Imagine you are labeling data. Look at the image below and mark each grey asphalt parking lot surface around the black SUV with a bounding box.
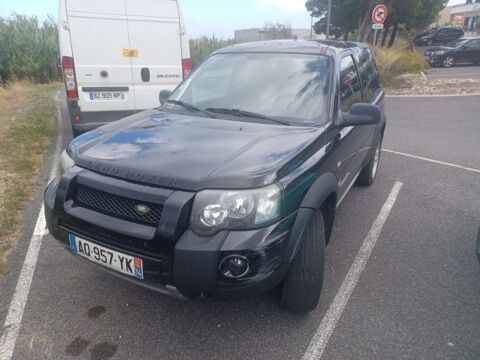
[0,96,480,360]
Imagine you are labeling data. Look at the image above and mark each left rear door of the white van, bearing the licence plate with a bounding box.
[67,0,135,111]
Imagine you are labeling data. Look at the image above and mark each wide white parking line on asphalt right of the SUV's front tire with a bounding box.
[303,182,403,360]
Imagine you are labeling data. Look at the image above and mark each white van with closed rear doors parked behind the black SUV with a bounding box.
[58,0,191,136]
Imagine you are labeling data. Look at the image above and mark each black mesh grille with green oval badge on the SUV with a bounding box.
[76,185,163,225]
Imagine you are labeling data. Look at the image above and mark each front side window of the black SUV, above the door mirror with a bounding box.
[340,56,362,112]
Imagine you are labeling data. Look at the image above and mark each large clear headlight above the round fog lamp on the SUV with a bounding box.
[190,185,282,235]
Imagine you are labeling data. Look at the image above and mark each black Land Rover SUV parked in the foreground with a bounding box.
[45,40,386,312]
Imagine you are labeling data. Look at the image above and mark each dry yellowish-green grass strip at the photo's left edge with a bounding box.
[0,83,59,272]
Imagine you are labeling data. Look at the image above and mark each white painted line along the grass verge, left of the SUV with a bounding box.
[0,99,63,360]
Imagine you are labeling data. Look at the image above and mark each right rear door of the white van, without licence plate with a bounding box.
[125,0,183,110]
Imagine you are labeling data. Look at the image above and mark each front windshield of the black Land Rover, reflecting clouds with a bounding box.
[167,53,331,125]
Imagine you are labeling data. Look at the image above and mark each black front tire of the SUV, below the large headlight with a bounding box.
[280,211,325,313]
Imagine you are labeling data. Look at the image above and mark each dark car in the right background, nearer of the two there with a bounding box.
[425,38,480,67]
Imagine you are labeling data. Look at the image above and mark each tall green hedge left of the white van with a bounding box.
[0,15,61,83]
